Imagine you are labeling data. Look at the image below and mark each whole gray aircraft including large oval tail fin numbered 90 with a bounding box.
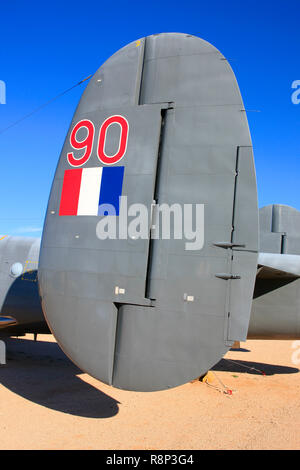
[0,33,300,391]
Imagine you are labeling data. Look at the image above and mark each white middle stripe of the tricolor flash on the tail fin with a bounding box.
[77,167,102,215]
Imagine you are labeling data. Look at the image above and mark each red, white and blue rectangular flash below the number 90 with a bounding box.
[59,166,124,216]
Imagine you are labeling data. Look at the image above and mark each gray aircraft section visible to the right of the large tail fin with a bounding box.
[248,204,300,339]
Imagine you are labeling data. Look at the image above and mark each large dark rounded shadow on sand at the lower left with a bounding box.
[0,338,119,418]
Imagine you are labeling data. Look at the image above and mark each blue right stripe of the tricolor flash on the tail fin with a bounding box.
[98,166,124,215]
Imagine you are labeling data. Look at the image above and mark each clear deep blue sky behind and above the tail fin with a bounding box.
[0,0,300,236]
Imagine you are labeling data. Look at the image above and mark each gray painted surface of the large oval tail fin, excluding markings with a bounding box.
[39,33,258,391]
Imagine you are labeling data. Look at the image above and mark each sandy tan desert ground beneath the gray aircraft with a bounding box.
[0,335,300,450]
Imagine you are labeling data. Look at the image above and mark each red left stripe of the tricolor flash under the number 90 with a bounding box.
[59,168,82,215]
